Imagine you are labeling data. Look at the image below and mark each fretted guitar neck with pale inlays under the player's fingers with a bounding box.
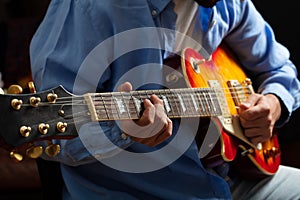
[84,88,222,121]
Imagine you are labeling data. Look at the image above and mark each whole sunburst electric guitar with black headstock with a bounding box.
[0,45,280,178]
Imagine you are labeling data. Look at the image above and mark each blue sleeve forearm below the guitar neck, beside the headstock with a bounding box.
[35,122,132,166]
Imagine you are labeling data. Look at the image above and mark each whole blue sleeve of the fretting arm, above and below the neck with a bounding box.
[30,0,138,165]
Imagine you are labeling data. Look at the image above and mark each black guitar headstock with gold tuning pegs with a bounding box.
[0,82,86,161]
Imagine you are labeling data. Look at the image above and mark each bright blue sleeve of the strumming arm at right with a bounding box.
[226,0,300,126]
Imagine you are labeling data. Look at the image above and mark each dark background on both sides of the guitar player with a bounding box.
[0,0,300,200]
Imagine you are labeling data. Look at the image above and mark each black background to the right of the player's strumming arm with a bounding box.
[253,0,300,154]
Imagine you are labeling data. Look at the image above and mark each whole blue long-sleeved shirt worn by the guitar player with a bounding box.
[30,0,300,199]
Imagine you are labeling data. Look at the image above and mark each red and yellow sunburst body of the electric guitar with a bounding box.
[181,44,280,178]
